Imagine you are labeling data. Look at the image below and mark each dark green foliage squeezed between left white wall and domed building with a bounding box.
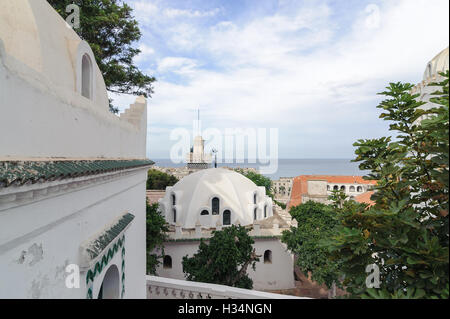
[146,202,169,275]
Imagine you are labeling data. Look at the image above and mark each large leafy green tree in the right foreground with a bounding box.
[328,71,449,298]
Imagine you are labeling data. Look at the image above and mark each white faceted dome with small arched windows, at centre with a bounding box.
[159,168,272,228]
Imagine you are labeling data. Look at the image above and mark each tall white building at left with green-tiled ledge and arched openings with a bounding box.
[0,0,152,299]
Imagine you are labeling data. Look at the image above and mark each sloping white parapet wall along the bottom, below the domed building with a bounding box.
[146,276,310,299]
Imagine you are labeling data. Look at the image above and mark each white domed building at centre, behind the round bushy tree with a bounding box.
[157,168,295,291]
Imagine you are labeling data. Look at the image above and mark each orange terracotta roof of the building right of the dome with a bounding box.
[288,175,377,208]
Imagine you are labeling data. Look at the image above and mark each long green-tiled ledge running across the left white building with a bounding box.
[0,160,154,187]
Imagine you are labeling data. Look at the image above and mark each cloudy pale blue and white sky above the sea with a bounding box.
[112,0,449,159]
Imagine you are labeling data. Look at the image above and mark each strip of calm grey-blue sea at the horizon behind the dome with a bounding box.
[154,159,368,180]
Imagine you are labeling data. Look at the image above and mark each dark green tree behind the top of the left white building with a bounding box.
[47,0,156,113]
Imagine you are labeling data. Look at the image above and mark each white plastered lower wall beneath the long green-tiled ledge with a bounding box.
[0,169,147,298]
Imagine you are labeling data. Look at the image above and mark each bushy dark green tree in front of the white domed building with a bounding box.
[182,225,259,289]
